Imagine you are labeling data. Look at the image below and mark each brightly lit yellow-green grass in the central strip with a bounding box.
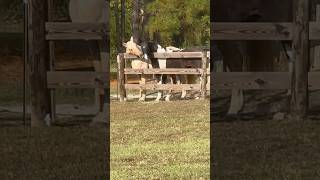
[111,101,210,179]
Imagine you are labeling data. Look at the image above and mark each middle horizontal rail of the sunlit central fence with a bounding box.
[124,68,202,75]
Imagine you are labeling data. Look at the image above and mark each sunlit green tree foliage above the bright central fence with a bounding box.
[146,0,210,46]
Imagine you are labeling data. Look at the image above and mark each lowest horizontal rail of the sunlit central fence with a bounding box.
[125,84,201,91]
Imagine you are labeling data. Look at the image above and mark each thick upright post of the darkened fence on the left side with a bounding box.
[28,0,50,127]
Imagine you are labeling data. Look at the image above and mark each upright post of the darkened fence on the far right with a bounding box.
[291,0,309,120]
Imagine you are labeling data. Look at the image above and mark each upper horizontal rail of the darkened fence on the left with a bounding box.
[46,22,108,40]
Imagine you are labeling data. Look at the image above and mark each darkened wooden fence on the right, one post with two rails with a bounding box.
[211,0,320,119]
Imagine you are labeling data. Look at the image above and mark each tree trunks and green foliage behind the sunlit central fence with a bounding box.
[110,0,210,68]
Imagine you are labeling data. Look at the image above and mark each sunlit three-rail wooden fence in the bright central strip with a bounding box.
[118,52,210,102]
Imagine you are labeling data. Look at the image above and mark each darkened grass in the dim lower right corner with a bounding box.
[211,119,320,180]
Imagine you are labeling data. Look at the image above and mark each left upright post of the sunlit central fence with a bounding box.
[117,53,126,102]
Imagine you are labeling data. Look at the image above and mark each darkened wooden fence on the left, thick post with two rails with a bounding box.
[28,0,109,126]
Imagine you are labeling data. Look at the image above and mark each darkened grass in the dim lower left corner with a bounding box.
[0,126,107,180]
